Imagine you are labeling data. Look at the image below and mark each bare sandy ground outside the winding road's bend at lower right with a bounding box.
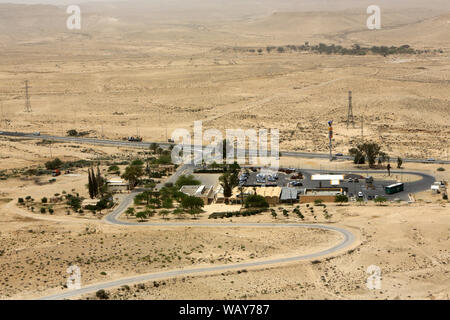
[84,205,450,299]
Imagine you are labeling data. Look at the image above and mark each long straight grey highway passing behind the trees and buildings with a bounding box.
[0,131,450,164]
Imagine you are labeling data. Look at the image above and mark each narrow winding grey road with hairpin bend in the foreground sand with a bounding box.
[42,192,355,300]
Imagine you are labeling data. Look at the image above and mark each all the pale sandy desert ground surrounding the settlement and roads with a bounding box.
[0,0,450,299]
